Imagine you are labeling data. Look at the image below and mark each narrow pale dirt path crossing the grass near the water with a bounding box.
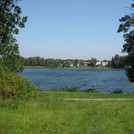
[64,98,134,101]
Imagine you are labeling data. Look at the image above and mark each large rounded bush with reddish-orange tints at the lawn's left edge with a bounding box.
[0,70,36,99]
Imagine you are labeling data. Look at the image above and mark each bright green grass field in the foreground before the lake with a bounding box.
[0,91,134,134]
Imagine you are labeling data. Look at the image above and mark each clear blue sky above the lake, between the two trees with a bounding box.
[16,0,132,60]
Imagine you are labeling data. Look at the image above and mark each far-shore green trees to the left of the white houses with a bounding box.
[21,56,102,67]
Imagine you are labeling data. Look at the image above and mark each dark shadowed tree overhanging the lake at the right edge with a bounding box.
[118,0,134,82]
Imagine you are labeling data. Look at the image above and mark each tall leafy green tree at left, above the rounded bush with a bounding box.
[0,0,27,72]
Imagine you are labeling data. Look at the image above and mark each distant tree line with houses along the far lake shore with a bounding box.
[21,54,127,68]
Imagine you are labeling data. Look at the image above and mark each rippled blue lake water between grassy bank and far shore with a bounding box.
[21,68,134,93]
